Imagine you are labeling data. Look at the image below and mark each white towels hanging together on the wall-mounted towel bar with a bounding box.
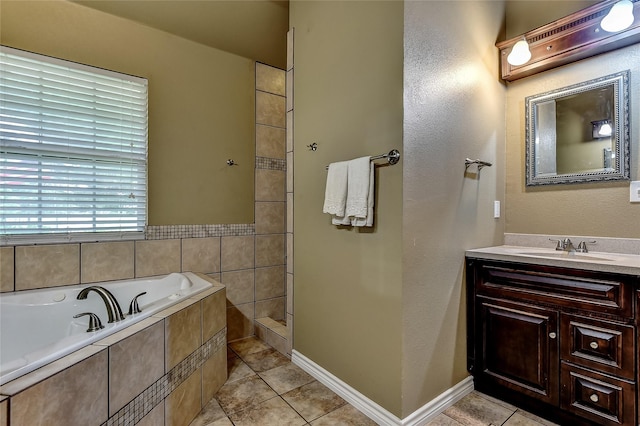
[323,157,375,226]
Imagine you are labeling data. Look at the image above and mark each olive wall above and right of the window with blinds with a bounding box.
[0,0,255,225]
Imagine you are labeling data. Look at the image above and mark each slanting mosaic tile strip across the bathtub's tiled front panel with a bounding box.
[102,327,227,426]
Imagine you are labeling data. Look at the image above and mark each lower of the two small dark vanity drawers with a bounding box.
[560,363,635,426]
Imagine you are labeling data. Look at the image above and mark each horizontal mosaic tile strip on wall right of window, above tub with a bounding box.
[146,223,256,240]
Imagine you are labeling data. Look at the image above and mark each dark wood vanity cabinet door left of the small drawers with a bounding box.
[476,298,559,405]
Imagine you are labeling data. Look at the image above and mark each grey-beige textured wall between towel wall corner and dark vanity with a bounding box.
[402,1,505,416]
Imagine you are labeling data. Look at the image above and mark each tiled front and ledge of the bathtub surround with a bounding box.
[0,274,227,426]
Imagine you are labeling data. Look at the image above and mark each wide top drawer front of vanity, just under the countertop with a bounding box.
[475,262,633,318]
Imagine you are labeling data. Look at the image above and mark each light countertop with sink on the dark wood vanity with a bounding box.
[465,245,640,275]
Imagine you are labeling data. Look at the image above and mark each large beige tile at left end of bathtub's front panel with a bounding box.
[10,349,109,426]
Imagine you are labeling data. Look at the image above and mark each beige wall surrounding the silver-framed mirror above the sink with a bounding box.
[506,44,640,240]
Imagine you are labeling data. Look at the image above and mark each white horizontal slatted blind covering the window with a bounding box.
[0,46,147,244]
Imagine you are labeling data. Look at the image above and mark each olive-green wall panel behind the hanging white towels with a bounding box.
[289,1,403,415]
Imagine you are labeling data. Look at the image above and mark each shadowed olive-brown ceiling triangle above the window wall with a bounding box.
[71,0,289,69]
